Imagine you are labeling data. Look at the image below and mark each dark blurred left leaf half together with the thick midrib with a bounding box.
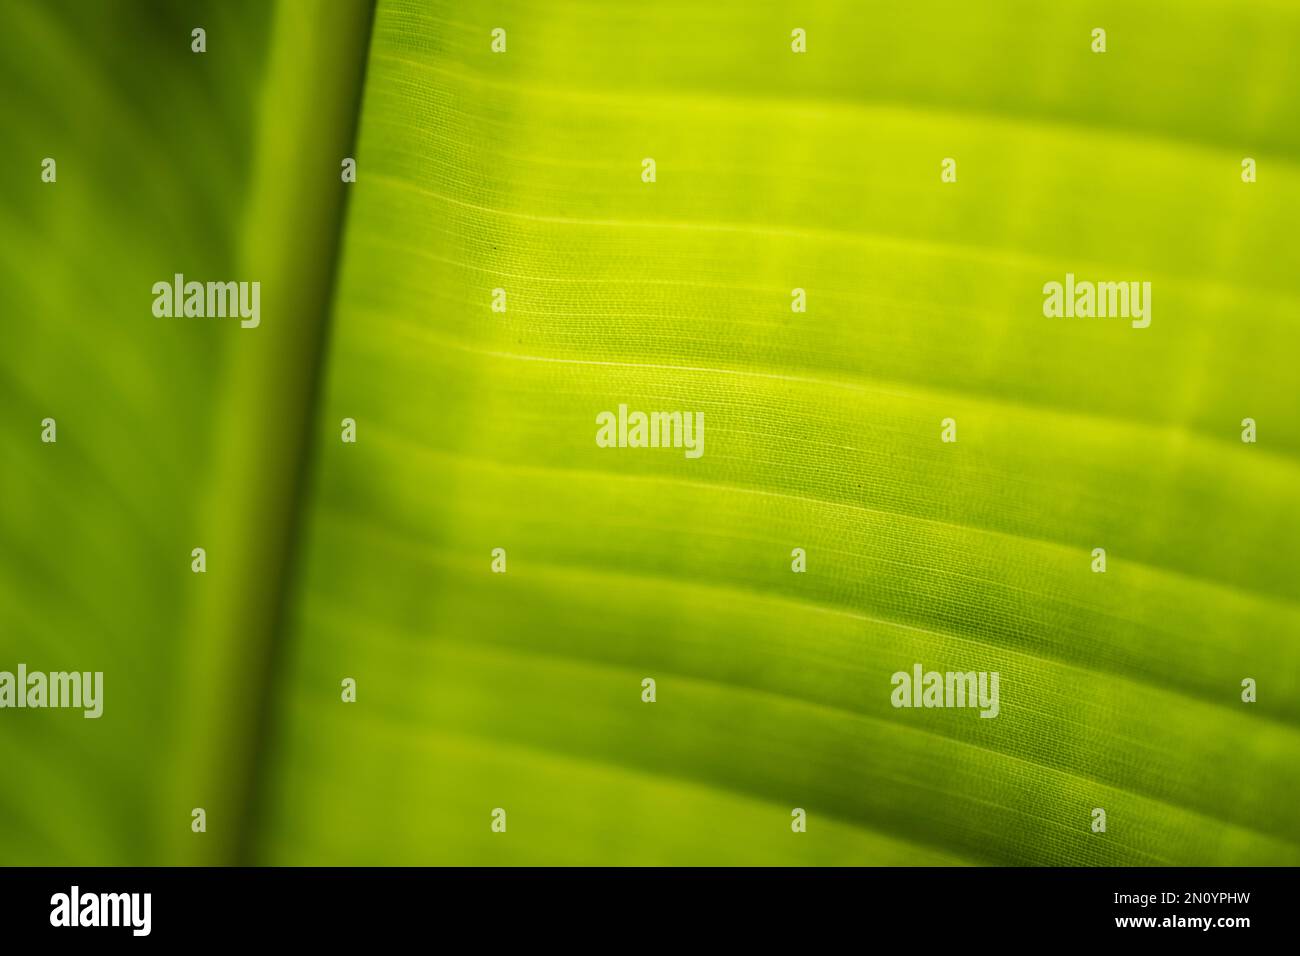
[0,0,369,865]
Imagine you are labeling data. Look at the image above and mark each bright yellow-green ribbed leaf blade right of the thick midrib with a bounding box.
[256,0,1300,865]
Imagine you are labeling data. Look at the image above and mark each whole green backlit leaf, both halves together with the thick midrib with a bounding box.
[0,0,1300,865]
